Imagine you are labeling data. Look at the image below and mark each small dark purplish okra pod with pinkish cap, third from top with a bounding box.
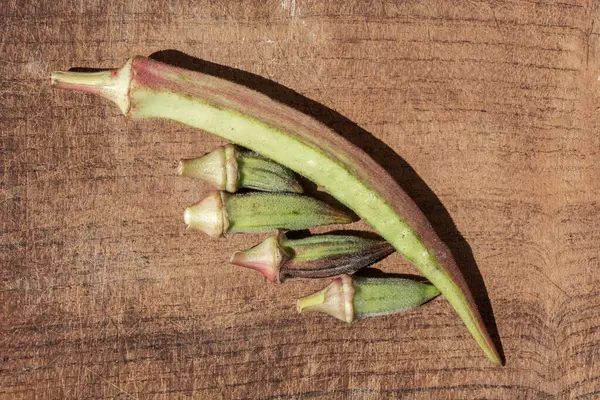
[231,234,395,282]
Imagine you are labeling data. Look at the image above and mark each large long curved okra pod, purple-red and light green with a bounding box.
[52,56,502,365]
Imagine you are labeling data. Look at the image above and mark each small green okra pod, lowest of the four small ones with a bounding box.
[296,275,440,322]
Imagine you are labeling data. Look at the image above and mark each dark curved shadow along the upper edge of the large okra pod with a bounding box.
[150,50,504,360]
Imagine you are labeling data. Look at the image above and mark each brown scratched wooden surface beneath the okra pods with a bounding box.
[0,0,600,399]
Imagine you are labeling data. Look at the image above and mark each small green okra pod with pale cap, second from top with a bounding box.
[184,191,355,237]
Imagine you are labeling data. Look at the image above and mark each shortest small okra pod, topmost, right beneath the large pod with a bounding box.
[177,144,303,193]
